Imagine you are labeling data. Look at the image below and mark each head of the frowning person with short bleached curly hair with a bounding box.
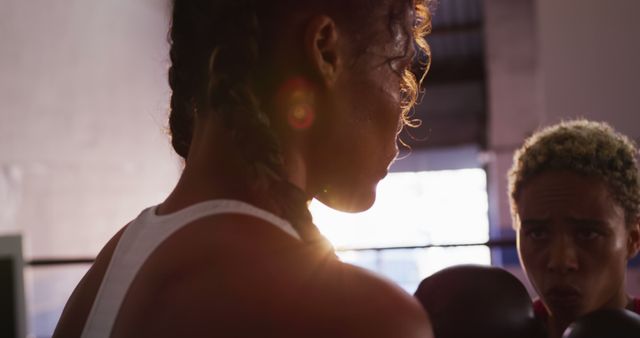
[509,120,640,338]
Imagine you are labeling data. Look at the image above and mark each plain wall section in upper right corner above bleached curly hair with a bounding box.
[536,0,640,135]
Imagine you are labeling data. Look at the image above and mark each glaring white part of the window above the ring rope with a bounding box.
[310,169,489,250]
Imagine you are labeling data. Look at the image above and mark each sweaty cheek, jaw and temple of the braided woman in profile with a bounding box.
[308,8,415,211]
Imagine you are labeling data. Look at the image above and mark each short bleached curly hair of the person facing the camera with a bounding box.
[509,119,640,228]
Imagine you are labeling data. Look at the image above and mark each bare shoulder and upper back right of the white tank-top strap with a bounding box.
[113,215,431,338]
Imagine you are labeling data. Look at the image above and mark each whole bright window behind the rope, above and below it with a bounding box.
[310,169,491,292]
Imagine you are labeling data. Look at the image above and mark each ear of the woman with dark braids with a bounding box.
[304,15,342,86]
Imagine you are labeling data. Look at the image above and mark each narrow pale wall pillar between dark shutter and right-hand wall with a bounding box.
[484,0,541,240]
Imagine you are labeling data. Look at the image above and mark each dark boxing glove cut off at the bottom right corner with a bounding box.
[562,309,640,338]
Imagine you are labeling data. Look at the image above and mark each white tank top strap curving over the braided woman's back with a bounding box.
[81,200,300,338]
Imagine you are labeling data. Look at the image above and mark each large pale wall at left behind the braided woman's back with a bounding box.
[0,0,175,337]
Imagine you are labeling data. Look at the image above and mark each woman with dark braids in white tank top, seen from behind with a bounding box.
[54,0,432,337]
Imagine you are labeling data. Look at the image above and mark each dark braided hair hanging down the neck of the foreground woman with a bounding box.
[169,0,430,247]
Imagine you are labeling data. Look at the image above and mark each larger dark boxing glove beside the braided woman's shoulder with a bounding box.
[415,265,544,338]
